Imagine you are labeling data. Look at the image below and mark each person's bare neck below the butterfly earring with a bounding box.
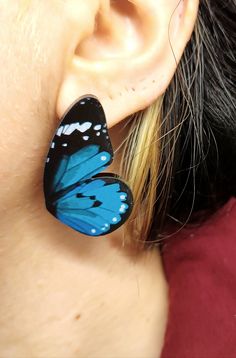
[0,196,170,357]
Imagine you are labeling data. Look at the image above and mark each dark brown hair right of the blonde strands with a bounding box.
[148,0,236,244]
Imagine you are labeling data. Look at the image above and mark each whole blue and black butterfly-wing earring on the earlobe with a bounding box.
[44,95,133,236]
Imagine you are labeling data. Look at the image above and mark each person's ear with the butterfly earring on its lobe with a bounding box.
[57,0,199,127]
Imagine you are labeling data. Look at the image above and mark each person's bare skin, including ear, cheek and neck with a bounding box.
[0,0,198,358]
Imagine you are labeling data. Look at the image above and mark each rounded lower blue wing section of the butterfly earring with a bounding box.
[55,177,132,236]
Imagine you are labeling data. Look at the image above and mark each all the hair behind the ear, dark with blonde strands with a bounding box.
[120,0,236,247]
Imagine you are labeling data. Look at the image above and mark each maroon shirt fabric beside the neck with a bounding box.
[161,198,236,358]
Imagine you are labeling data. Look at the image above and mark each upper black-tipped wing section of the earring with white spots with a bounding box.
[44,96,113,199]
